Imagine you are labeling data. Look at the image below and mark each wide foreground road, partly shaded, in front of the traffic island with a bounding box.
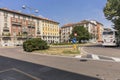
[0,48,120,80]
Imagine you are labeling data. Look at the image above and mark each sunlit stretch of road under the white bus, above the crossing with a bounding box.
[84,44,120,58]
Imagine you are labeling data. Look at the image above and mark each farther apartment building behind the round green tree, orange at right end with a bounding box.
[61,20,103,42]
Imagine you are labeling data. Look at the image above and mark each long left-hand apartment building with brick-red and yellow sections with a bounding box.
[0,8,59,46]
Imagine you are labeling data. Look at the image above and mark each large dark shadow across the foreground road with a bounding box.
[0,56,101,80]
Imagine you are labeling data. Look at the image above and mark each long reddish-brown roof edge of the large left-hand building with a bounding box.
[0,8,59,24]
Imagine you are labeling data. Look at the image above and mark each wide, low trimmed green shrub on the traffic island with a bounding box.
[23,38,49,52]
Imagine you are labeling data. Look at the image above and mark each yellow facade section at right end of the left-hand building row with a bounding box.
[42,20,59,43]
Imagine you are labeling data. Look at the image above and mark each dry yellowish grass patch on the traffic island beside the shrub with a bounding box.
[35,48,80,57]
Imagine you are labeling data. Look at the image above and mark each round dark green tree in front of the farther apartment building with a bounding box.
[70,26,91,43]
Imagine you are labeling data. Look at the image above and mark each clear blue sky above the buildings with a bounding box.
[0,0,112,27]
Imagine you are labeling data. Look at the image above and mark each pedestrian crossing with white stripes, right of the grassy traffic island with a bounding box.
[80,54,120,62]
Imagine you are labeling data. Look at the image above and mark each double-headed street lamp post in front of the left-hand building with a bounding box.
[22,5,39,39]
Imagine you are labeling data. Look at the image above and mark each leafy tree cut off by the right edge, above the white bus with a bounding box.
[103,0,120,35]
